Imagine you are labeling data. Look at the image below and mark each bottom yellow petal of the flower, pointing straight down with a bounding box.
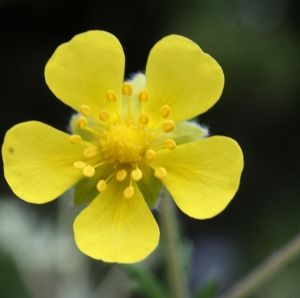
[74,178,159,263]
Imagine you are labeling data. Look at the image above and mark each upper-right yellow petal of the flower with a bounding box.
[144,35,224,127]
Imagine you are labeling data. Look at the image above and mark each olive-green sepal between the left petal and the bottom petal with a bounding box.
[73,164,114,206]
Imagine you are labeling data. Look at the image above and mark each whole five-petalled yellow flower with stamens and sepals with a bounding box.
[2,31,243,263]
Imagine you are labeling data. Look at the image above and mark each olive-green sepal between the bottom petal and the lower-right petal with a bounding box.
[136,164,162,208]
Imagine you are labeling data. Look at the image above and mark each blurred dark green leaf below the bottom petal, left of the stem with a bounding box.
[122,265,170,298]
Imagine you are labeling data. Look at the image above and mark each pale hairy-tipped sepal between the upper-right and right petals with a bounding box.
[153,121,208,147]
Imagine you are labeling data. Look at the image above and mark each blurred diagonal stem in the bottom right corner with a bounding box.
[219,234,300,298]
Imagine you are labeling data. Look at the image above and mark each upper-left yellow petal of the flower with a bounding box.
[45,31,125,120]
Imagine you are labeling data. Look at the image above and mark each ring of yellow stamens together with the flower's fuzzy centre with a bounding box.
[70,82,176,199]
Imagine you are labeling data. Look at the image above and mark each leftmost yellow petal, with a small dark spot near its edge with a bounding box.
[2,121,86,204]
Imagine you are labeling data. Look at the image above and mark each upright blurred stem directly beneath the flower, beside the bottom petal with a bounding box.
[161,189,189,298]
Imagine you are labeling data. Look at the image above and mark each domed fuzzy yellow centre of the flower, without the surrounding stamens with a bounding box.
[100,122,150,165]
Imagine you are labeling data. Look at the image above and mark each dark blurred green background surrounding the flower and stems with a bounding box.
[0,0,300,298]
